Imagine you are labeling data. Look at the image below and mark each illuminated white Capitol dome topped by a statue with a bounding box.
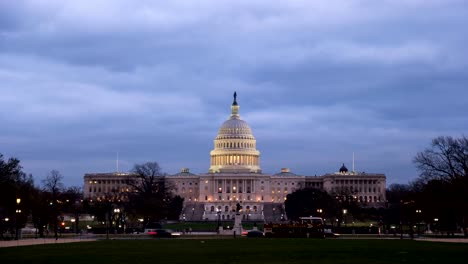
[209,93,261,173]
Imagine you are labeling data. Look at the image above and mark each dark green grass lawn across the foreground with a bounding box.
[0,238,468,264]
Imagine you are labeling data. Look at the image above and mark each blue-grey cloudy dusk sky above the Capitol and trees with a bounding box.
[0,0,468,186]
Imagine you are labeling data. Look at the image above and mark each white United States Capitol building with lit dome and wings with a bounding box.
[84,94,386,221]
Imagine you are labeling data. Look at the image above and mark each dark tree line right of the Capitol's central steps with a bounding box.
[285,136,468,236]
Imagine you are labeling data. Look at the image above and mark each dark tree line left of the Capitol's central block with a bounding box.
[0,154,183,239]
